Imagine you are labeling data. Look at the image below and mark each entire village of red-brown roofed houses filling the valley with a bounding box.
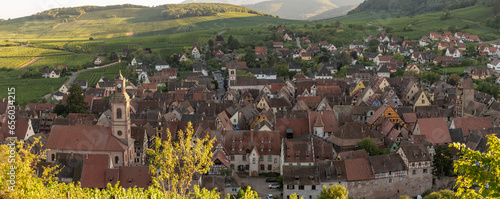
[0,24,500,198]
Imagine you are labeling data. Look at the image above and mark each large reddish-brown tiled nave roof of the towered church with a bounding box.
[46,125,127,151]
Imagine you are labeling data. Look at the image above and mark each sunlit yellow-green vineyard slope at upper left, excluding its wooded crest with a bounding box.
[0,8,300,40]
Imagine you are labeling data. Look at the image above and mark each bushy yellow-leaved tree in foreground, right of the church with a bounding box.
[148,122,215,198]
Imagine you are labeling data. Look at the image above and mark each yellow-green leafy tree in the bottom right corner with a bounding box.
[450,135,500,198]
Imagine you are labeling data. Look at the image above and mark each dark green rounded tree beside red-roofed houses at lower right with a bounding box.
[432,146,453,177]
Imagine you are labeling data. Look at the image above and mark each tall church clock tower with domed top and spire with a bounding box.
[110,71,133,146]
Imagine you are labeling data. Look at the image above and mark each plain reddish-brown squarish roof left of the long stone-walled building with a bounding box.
[344,158,375,181]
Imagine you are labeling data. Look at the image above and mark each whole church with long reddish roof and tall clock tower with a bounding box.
[46,72,145,169]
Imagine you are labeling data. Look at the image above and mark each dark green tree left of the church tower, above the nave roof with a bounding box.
[66,83,89,113]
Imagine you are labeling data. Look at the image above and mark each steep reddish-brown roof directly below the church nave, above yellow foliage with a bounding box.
[80,154,109,189]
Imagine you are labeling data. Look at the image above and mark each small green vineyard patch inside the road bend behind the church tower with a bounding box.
[76,63,123,87]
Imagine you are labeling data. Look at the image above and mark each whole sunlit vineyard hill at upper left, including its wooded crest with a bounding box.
[0,3,298,39]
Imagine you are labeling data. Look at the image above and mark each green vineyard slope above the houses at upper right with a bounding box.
[324,6,500,40]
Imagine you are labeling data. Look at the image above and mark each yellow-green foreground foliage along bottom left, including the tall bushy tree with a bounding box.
[0,123,264,199]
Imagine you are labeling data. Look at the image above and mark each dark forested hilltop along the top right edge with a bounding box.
[348,0,497,15]
